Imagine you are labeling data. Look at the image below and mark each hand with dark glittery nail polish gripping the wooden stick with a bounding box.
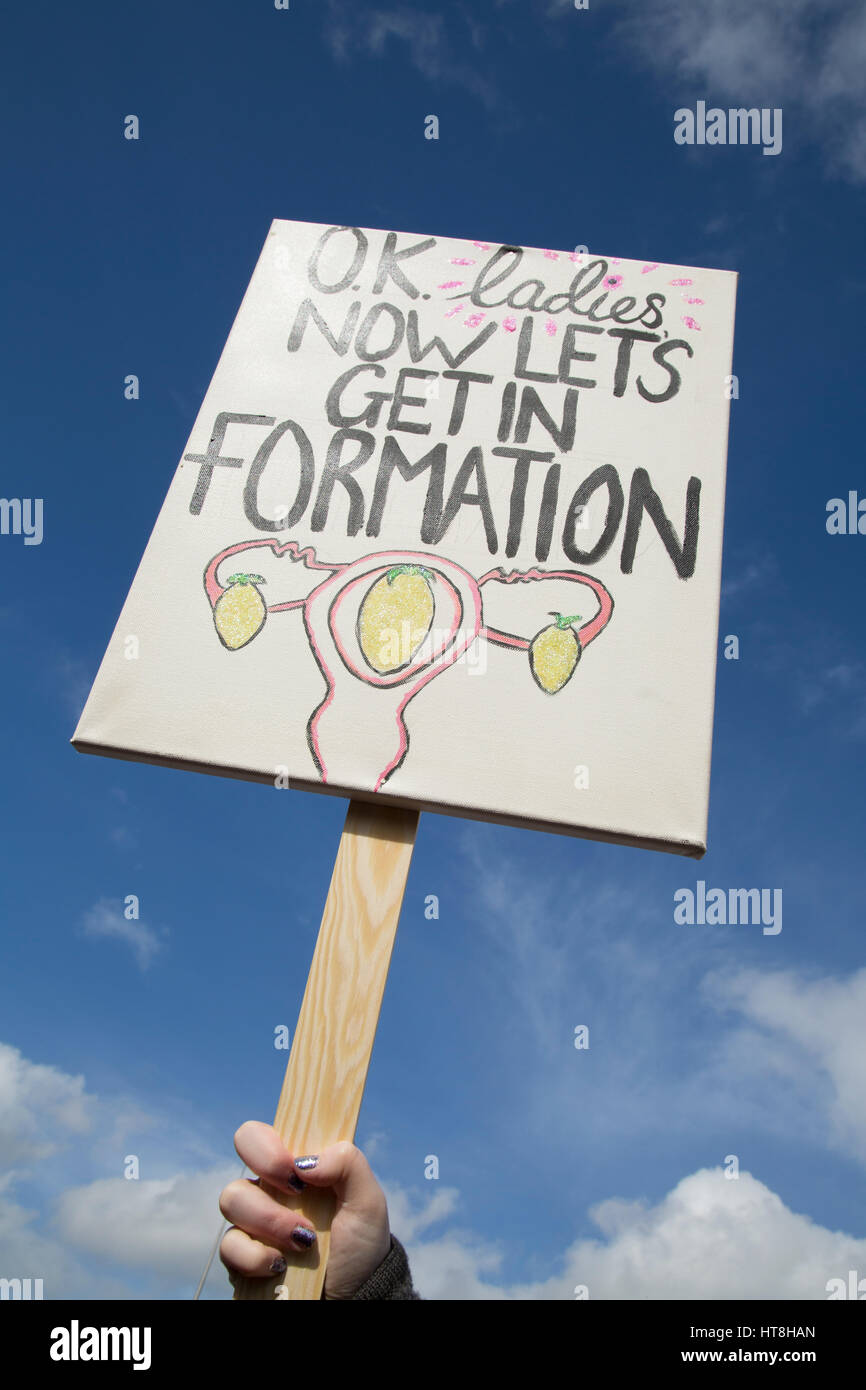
[220,1120,391,1298]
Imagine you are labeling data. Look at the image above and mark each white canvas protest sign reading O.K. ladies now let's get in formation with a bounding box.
[74,221,737,856]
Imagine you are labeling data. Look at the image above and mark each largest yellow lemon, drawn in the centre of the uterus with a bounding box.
[357,564,435,676]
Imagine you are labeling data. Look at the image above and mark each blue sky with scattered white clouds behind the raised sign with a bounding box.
[0,0,866,1298]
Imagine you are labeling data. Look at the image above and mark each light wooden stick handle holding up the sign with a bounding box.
[235,801,418,1300]
